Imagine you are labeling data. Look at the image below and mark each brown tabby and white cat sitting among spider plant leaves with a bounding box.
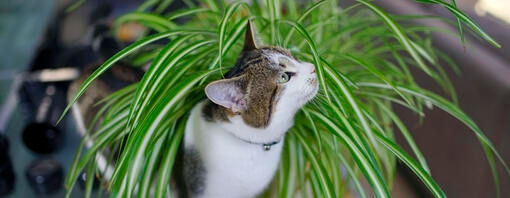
[183,22,318,198]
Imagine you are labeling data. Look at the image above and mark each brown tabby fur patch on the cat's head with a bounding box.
[203,23,295,128]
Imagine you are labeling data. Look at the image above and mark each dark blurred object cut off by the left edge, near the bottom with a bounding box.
[0,132,15,196]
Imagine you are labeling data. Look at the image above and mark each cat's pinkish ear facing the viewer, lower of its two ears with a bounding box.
[205,78,248,113]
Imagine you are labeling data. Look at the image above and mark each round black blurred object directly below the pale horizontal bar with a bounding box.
[23,122,64,154]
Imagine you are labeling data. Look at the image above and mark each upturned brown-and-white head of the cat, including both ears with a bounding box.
[205,22,318,128]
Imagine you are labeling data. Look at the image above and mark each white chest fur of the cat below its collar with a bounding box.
[184,102,283,198]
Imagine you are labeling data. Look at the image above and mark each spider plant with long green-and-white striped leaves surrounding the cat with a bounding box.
[64,0,510,197]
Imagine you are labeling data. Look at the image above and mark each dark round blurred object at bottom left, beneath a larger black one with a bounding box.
[25,158,64,195]
